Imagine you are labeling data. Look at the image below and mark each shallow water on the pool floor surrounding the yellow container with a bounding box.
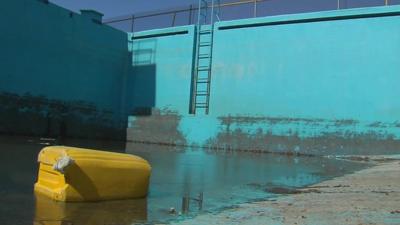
[0,136,367,225]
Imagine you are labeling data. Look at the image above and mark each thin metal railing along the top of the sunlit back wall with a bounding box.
[103,0,400,32]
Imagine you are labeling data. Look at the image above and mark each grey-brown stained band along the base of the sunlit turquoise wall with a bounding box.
[128,113,400,155]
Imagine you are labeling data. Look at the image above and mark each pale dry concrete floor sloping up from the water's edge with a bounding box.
[171,156,400,225]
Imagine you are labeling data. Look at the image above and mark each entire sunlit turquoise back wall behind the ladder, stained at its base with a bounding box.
[127,6,400,155]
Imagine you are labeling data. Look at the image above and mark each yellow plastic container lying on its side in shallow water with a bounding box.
[35,146,151,202]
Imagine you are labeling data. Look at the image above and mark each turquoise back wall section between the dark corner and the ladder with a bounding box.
[128,26,195,144]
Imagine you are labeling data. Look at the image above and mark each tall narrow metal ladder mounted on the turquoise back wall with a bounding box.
[190,0,220,114]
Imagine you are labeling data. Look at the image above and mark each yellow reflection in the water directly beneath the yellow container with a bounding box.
[33,195,147,225]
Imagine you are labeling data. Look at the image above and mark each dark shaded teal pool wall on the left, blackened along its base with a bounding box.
[0,0,132,139]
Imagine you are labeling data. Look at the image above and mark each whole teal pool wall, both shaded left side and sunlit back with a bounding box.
[0,0,400,155]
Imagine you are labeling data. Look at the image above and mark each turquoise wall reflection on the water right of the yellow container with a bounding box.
[126,143,363,220]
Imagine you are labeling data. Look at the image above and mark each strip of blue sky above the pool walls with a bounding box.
[50,0,400,31]
